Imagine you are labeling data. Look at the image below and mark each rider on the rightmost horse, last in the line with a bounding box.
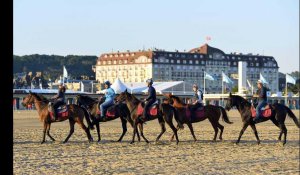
[253,80,267,122]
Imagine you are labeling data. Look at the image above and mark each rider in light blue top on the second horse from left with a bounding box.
[100,80,116,119]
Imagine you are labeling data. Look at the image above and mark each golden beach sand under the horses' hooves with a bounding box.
[13,111,300,174]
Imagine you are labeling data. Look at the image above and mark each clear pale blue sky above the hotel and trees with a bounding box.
[13,0,299,73]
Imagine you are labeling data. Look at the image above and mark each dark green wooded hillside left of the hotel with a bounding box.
[13,54,97,80]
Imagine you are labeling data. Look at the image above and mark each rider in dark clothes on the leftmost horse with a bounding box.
[51,84,66,120]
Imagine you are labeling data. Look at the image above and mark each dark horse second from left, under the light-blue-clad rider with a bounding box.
[74,95,136,142]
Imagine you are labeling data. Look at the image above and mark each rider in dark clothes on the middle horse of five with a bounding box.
[142,78,156,120]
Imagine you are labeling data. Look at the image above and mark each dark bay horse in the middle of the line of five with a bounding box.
[116,89,179,144]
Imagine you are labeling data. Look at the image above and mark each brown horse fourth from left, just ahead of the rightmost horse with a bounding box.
[164,93,232,141]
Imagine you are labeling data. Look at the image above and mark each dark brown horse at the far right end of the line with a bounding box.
[225,92,300,145]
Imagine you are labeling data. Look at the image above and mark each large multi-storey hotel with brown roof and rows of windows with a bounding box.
[93,44,279,93]
